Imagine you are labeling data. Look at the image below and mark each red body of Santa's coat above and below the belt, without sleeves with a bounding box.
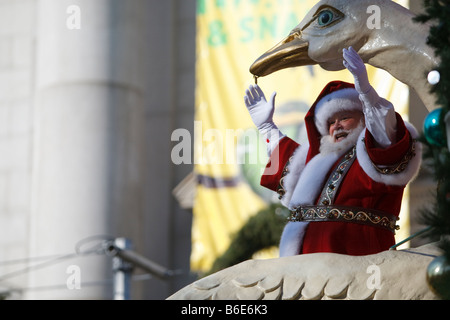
[301,160,404,255]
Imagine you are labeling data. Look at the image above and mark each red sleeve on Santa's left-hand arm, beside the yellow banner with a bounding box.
[261,137,300,191]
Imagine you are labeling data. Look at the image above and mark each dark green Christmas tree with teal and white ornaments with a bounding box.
[415,0,450,260]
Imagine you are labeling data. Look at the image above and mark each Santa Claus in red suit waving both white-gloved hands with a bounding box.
[244,47,422,256]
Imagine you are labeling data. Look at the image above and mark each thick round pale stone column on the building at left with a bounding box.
[25,0,145,299]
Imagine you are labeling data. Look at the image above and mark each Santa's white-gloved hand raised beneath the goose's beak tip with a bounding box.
[244,84,277,136]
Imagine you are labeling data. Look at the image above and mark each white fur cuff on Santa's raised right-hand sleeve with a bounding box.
[356,121,422,186]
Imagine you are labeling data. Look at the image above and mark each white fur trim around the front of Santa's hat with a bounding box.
[314,88,363,136]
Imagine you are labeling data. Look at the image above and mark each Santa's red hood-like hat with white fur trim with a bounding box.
[305,80,362,162]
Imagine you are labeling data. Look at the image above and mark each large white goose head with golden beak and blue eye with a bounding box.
[250,0,438,110]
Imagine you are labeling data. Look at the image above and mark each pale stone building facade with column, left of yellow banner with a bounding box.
[0,0,195,299]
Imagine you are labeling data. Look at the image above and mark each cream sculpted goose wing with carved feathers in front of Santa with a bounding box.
[168,244,440,300]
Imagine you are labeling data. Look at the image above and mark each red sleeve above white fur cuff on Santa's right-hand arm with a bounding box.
[366,113,411,165]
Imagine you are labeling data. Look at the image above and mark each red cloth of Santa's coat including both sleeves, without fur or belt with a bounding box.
[261,114,421,255]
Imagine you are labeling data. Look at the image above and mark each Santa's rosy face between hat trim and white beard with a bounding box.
[328,110,363,142]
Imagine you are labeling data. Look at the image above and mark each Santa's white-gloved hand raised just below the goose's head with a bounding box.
[342,46,371,94]
